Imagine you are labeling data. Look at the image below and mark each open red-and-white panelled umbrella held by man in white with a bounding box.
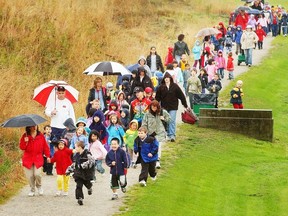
[33,80,79,106]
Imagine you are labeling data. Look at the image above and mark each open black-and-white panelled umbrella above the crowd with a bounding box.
[83,61,131,76]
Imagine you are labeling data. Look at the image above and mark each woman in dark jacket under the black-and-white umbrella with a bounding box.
[86,77,111,115]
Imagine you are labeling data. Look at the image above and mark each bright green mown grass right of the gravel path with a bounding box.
[121,37,288,216]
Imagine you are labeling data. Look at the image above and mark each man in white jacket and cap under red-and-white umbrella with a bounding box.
[45,86,75,139]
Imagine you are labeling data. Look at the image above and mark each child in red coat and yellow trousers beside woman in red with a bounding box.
[47,139,76,196]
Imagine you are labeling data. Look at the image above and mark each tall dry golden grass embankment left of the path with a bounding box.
[0,0,238,203]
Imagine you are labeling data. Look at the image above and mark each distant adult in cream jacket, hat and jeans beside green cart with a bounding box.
[241,25,259,67]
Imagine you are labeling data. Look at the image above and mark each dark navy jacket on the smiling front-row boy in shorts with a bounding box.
[105,147,128,175]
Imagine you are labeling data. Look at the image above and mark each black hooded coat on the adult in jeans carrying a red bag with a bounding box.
[155,73,188,112]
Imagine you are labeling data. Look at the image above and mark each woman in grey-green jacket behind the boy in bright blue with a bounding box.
[142,100,171,169]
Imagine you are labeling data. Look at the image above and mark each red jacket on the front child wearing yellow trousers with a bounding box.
[51,146,73,175]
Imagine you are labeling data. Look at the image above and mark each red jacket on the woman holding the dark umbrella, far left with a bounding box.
[19,133,50,169]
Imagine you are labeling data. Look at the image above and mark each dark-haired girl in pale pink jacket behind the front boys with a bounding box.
[89,130,107,180]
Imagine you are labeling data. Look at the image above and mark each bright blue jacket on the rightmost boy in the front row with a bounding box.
[134,136,159,163]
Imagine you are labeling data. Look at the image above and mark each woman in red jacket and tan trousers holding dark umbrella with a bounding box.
[19,125,50,197]
